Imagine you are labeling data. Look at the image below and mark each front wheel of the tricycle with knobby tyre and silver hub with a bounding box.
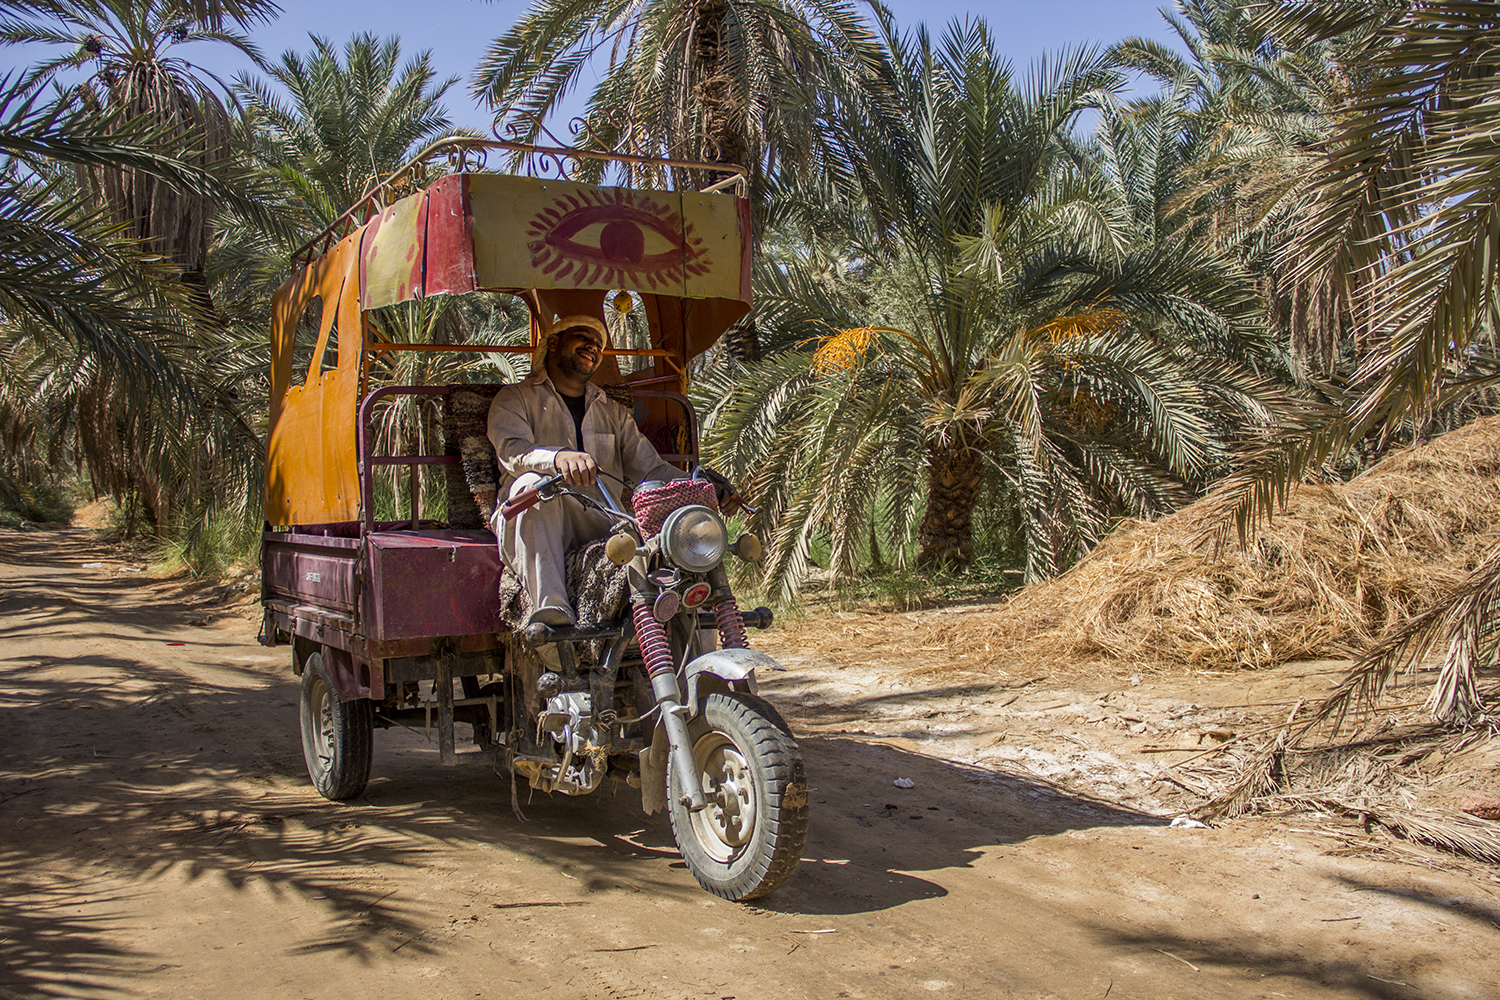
[666,693,807,901]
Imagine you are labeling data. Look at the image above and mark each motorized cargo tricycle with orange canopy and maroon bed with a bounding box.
[261,138,807,900]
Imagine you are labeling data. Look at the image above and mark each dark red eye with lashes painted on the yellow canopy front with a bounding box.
[527,187,710,288]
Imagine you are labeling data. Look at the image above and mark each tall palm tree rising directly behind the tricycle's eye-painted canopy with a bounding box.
[473,0,879,360]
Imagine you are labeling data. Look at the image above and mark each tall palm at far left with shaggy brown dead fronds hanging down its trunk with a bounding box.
[0,0,276,532]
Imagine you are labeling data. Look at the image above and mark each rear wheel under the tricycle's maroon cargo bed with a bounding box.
[302,652,375,801]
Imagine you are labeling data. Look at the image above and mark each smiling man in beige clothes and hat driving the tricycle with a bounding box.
[489,316,683,625]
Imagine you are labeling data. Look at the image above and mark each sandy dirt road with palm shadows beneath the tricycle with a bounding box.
[0,529,1500,1000]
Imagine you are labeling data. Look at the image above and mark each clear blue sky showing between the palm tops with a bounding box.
[0,0,1175,132]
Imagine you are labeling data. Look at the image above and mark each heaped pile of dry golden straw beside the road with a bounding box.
[944,417,1500,670]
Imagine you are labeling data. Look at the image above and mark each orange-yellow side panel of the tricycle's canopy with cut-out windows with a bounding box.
[266,231,363,525]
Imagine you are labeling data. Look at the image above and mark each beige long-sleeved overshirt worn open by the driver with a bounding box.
[489,369,684,510]
